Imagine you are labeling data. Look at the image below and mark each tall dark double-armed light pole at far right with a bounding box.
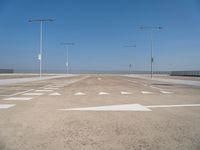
[140,26,163,78]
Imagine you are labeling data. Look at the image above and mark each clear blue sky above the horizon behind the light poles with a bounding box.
[0,0,200,70]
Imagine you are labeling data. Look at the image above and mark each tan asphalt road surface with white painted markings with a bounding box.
[0,75,200,150]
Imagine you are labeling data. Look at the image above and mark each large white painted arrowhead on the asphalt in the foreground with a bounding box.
[59,104,151,111]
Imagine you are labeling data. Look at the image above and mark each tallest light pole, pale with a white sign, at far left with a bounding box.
[28,19,53,78]
